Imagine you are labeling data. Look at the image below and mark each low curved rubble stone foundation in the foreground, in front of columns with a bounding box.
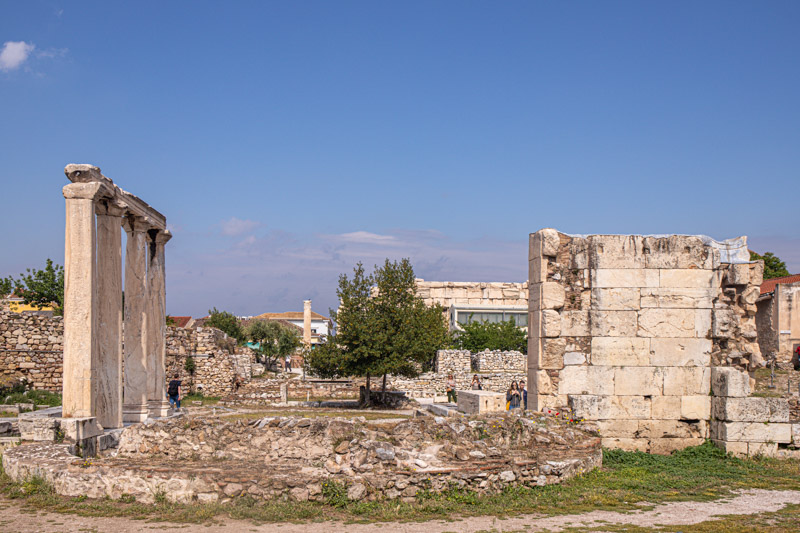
[3,415,602,503]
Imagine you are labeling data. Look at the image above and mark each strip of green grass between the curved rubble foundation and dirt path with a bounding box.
[0,443,800,533]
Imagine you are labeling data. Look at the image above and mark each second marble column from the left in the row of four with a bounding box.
[94,201,124,428]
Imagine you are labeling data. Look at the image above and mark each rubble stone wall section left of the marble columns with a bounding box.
[0,311,64,392]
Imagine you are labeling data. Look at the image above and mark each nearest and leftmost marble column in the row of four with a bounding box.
[61,182,104,418]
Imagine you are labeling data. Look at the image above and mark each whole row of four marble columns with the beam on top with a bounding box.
[62,165,171,428]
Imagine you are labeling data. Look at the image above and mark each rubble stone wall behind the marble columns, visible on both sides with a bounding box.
[0,312,250,396]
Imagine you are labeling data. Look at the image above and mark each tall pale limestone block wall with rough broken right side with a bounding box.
[528,229,763,453]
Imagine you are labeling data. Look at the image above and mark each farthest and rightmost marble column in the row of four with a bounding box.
[147,230,172,417]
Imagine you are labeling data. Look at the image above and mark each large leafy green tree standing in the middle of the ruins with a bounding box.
[306,259,448,402]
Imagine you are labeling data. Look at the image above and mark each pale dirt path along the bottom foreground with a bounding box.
[0,489,800,533]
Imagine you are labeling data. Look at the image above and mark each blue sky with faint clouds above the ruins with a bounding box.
[0,0,800,316]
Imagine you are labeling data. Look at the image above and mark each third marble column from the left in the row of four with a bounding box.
[122,216,149,422]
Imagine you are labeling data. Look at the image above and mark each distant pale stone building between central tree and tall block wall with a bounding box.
[416,279,528,330]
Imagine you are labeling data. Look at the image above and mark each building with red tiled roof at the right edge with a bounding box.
[756,274,800,362]
